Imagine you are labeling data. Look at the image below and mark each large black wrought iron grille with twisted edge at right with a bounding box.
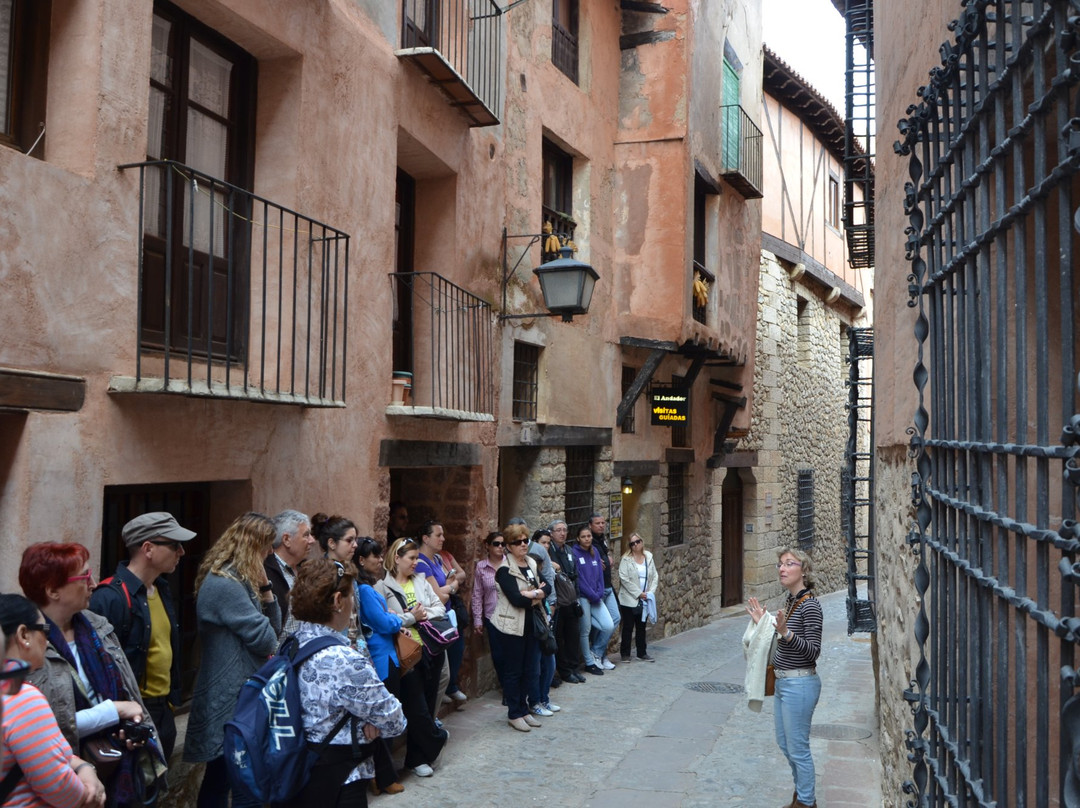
[895,0,1080,808]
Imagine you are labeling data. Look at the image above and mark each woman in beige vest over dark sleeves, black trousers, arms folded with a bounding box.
[491,525,550,732]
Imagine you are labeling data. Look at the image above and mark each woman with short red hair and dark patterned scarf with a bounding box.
[18,542,165,805]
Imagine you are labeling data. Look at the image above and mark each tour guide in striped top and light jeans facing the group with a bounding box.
[746,548,822,808]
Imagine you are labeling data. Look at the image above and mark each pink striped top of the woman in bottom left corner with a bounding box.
[0,685,85,808]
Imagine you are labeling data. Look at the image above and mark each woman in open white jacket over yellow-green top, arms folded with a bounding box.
[375,539,446,743]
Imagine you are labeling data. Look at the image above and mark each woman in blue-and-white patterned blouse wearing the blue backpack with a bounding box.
[288,558,405,808]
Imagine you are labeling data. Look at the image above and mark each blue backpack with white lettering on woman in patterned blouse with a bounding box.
[225,634,351,804]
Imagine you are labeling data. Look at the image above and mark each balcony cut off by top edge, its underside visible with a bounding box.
[397,0,503,126]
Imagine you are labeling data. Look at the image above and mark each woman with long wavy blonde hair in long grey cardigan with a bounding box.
[184,513,281,808]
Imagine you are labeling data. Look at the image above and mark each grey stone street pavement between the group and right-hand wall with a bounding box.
[384,592,882,808]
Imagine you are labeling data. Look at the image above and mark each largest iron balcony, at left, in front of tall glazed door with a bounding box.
[109,160,349,407]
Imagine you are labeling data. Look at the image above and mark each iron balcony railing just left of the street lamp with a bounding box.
[390,272,495,420]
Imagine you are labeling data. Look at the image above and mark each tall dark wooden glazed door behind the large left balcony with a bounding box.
[141,2,256,360]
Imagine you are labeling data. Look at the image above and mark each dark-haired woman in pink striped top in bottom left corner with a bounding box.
[0,594,105,808]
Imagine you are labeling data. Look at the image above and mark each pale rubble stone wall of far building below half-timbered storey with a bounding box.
[743,251,860,600]
